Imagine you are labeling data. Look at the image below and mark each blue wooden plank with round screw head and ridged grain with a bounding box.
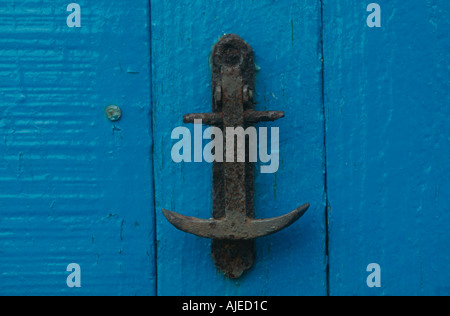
[0,0,156,295]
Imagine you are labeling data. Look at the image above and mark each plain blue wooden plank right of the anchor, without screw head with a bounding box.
[324,0,450,295]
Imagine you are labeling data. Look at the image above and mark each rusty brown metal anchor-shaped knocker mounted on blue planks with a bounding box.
[163,34,309,279]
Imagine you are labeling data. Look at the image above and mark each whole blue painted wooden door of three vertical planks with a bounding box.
[0,0,450,296]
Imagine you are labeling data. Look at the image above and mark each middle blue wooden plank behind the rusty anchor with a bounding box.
[152,0,326,295]
